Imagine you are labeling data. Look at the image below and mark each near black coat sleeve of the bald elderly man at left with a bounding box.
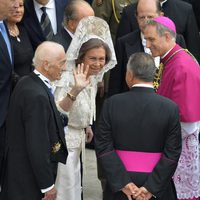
[23,94,54,189]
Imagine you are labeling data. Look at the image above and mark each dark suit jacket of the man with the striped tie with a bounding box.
[23,0,68,49]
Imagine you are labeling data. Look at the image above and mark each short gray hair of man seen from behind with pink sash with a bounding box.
[127,52,156,82]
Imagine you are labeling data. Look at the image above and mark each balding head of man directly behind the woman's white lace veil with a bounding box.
[64,0,94,33]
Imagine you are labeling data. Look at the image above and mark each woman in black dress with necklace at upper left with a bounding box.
[7,0,34,77]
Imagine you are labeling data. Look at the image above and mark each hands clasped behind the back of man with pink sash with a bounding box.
[122,183,152,200]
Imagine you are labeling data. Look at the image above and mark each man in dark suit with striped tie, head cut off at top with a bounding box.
[23,0,68,49]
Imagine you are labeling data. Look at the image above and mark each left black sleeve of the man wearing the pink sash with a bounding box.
[94,100,132,192]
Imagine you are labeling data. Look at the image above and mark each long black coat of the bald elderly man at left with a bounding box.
[2,73,67,200]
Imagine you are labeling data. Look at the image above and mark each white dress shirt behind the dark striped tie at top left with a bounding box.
[33,0,57,35]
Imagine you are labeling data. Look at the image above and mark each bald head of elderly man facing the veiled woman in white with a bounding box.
[33,41,66,81]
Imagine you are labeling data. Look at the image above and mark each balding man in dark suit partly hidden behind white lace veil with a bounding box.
[53,0,94,51]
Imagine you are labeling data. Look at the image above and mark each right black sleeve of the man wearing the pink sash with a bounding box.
[144,105,182,199]
